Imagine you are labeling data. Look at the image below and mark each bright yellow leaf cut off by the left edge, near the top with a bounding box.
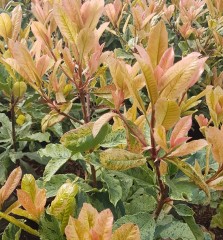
[0,13,12,42]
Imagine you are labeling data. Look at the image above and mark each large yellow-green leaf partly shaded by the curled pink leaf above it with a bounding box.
[60,122,109,153]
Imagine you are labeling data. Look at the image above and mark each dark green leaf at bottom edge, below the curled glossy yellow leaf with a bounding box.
[39,214,65,240]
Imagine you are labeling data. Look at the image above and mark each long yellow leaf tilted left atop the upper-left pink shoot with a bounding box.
[53,4,77,43]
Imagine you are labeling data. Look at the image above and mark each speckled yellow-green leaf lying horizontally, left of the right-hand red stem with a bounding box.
[100,148,146,170]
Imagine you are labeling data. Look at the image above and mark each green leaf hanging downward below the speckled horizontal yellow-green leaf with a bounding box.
[102,171,122,206]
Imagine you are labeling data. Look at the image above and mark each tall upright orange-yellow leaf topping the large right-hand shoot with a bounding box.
[147,21,168,68]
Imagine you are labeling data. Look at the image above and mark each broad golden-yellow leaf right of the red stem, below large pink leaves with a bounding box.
[155,98,180,130]
